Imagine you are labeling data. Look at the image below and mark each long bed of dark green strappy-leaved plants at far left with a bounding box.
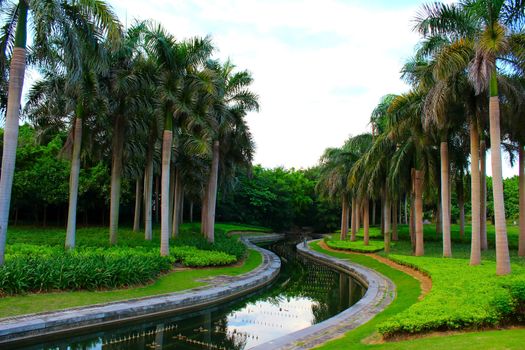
[0,245,174,295]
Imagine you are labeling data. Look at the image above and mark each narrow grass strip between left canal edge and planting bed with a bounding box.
[0,249,262,317]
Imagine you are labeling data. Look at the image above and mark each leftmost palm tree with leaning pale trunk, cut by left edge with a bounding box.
[0,0,120,265]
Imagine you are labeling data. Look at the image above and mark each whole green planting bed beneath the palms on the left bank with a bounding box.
[0,224,265,295]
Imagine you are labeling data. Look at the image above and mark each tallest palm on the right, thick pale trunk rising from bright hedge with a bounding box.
[418,0,525,275]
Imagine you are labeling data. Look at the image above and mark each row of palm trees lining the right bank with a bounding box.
[319,0,525,275]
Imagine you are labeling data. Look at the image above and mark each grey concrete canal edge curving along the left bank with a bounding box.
[0,234,284,345]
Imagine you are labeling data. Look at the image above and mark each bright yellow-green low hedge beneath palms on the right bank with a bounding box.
[378,255,525,338]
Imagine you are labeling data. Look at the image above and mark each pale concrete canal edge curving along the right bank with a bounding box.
[252,241,396,350]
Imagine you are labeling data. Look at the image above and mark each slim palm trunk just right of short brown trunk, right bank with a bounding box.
[440,141,452,258]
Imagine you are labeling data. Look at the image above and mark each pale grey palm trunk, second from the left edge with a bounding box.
[65,116,82,249]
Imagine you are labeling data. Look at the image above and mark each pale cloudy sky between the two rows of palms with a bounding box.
[105,0,517,177]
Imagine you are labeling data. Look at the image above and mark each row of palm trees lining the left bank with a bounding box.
[0,0,259,264]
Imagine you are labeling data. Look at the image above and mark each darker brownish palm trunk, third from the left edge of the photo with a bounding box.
[109,117,124,245]
